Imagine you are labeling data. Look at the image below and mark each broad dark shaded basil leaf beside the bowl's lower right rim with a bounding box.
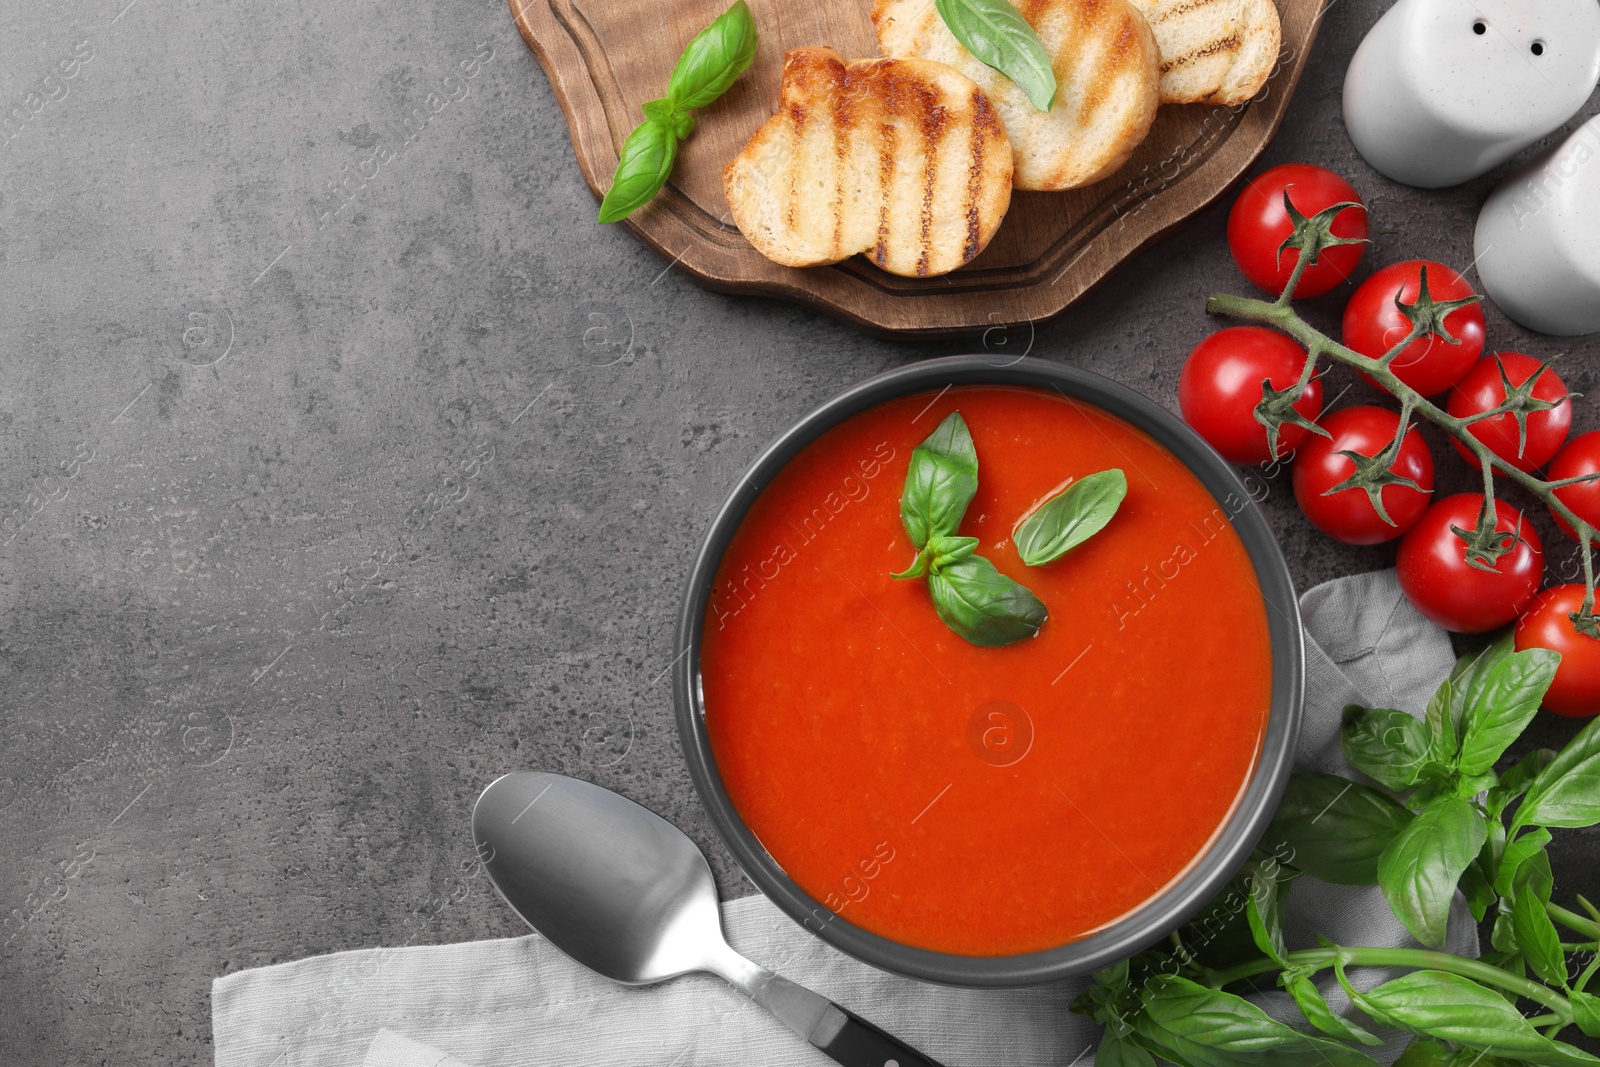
[1267,771,1413,886]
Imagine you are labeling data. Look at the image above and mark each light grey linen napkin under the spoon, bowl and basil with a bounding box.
[211,571,1478,1067]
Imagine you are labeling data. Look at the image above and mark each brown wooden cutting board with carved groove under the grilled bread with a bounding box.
[510,0,1325,334]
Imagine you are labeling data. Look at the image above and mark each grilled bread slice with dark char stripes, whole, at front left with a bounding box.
[722,48,1011,277]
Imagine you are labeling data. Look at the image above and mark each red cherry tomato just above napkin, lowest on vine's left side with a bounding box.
[1395,493,1544,633]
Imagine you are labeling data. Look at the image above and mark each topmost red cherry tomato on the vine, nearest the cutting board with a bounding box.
[1227,163,1366,296]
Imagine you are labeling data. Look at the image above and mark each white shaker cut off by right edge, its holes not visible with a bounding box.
[1474,115,1600,338]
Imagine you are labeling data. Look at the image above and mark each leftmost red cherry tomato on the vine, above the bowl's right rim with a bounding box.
[1178,326,1322,464]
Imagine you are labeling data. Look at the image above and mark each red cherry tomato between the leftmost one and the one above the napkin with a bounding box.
[1294,406,1434,544]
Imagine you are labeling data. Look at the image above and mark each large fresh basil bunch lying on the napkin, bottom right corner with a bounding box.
[1074,638,1600,1067]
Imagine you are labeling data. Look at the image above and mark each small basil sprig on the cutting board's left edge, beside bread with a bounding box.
[600,0,755,222]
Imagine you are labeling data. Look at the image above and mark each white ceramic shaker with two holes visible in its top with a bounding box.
[1344,0,1600,189]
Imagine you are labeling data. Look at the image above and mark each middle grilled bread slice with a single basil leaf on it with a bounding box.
[872,0,1160,189]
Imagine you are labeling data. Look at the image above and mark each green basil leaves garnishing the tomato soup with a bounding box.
[893,411,1128,648]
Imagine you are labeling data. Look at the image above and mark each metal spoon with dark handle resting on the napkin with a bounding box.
[472,771,939,1067]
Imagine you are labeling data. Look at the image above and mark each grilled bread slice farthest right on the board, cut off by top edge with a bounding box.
[1133,0,1283,107]
